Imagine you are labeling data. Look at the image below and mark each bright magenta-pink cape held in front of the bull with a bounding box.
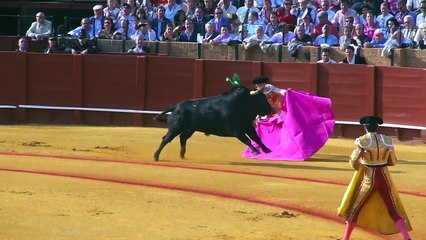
[243,90,334,161]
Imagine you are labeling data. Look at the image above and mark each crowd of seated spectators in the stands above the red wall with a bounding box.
[22,0,426,56]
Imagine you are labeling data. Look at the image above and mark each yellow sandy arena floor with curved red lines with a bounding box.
[0,126,426,240]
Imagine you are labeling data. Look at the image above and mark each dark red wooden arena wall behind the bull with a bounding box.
[0,52,426,139]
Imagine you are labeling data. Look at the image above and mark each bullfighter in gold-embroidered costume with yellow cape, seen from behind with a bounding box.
[338,116,411,240]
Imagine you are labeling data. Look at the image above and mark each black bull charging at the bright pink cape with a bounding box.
[154,87,271,161]
